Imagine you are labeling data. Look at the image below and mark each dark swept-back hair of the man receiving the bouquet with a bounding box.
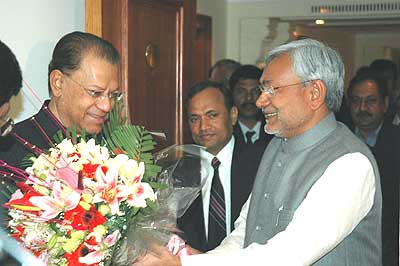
[48,31,120,90]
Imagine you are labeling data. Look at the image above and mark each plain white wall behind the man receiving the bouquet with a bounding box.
[0,0,85,121]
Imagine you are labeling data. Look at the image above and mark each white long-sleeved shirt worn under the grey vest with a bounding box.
[181,153,375,266]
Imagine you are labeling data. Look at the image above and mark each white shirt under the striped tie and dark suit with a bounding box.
[201,136,235,238]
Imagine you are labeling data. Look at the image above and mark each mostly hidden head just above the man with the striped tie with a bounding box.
[208,59,241,86]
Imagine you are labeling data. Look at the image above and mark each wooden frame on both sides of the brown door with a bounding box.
[85,0,197,144]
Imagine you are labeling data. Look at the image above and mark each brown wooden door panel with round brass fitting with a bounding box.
[128,0,180,148]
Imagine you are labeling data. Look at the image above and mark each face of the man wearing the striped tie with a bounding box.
[188,87,237,155]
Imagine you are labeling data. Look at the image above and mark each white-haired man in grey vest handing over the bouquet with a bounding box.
[137,39,382,266]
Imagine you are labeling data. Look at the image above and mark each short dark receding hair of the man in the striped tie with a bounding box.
[185,80,233,114]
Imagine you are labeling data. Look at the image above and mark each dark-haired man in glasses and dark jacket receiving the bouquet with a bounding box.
[0,32,121,166]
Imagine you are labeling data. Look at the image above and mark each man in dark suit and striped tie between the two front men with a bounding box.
[178,81,258,251]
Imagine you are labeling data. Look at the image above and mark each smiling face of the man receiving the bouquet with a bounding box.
[49,53,119,134]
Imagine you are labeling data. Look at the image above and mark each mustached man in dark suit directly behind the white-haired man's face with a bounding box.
[229,65,272,152]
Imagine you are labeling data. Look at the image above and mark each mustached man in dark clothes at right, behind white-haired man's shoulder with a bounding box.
[348,71,400,266]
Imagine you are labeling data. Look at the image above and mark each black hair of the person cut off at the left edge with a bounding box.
[0,41,22,106]
